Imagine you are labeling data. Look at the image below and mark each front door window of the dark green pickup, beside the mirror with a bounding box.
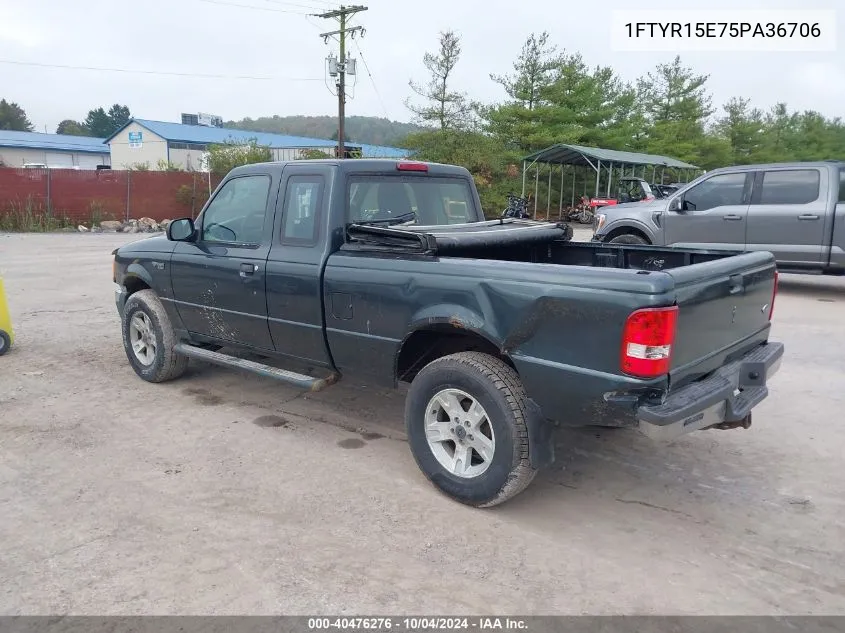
[202,175,270,244]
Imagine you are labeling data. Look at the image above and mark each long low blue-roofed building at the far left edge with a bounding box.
[0,130,110,169]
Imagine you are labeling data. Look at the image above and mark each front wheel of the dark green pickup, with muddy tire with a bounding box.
[121,290,188,382]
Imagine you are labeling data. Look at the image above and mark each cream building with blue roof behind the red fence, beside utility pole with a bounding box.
[105,117,409,170]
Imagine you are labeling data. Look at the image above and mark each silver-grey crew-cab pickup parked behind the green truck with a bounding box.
[593,161,845,275]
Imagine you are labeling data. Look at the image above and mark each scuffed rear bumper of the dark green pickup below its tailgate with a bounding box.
[636,343,783,440]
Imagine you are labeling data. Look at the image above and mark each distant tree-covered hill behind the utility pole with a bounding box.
[225,115,421,145]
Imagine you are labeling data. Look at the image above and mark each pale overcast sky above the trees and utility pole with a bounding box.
[0,0,845,132]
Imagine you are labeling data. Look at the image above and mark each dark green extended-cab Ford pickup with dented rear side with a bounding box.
[114,159,783,506]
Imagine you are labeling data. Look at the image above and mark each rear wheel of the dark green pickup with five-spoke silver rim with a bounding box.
[405,352,537,507]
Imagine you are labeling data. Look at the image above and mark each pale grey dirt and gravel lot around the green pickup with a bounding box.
[0,234,845,615]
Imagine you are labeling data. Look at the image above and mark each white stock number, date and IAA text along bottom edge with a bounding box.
[308,617,528,631]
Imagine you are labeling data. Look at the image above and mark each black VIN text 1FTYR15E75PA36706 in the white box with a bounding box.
[625,22,821,38]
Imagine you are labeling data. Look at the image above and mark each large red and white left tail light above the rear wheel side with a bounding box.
[621,306,678,378]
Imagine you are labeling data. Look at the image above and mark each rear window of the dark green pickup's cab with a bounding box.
[347,176,479,226]
